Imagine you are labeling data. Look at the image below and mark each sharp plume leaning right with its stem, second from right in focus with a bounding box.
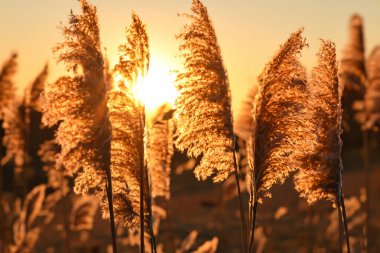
[248,29,309,252]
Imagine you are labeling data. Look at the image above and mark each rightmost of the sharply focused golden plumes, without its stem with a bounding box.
[294,40,342,203]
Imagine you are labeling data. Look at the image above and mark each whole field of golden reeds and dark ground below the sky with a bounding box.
[0,0,380,253]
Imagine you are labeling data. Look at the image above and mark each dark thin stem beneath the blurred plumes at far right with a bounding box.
[363,130,371,252]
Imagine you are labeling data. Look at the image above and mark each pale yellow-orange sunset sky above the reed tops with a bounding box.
[0,0,380,115]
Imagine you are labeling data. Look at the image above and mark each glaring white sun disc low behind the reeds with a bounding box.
[136,60,177,112]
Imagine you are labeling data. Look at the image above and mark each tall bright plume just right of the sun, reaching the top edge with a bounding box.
[174,0,234,182]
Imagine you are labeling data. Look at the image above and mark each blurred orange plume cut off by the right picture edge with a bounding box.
[363,46,380,131]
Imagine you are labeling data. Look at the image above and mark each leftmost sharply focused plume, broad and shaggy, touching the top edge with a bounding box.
[42,0,111,206]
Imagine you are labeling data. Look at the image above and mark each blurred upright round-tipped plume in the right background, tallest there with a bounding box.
[339,14,367,148]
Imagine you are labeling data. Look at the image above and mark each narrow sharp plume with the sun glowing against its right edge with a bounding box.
[108,14,149,229]
